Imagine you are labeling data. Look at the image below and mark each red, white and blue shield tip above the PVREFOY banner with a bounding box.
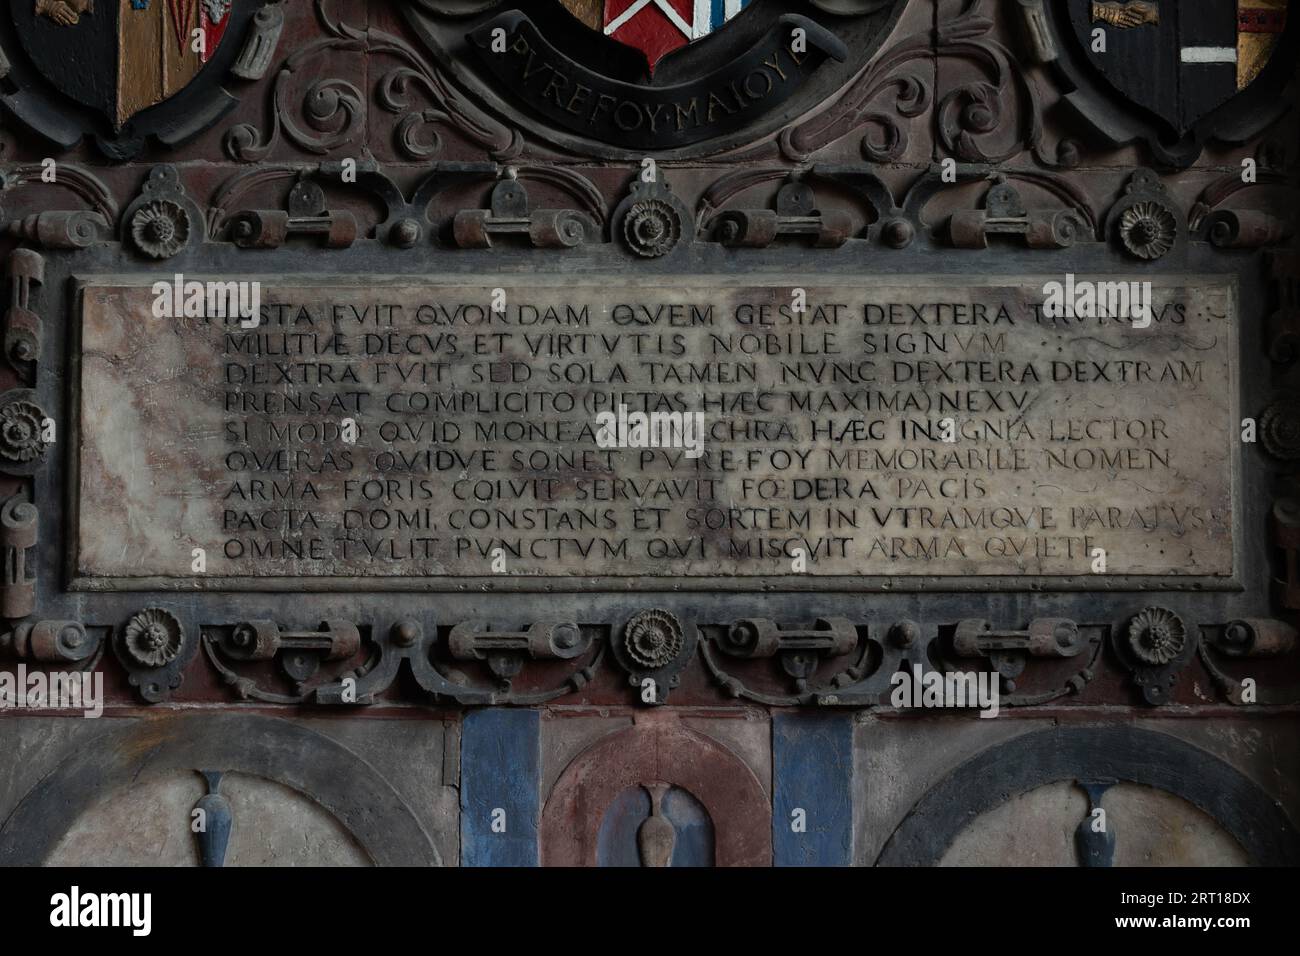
[562,0,750,74]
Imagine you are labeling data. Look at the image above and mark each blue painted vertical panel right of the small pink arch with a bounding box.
[772,713,853,866]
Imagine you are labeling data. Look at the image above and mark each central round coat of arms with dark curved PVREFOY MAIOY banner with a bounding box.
[436,0,906,151]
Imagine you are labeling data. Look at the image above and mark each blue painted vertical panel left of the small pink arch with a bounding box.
[460,708,542,866]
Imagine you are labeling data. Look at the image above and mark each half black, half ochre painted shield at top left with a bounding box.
[10,0,234,130]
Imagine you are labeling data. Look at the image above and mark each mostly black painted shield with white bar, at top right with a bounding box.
[1070,0,1287,134]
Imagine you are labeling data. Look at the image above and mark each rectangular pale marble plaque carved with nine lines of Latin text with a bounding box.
[72,276,1239,589]
